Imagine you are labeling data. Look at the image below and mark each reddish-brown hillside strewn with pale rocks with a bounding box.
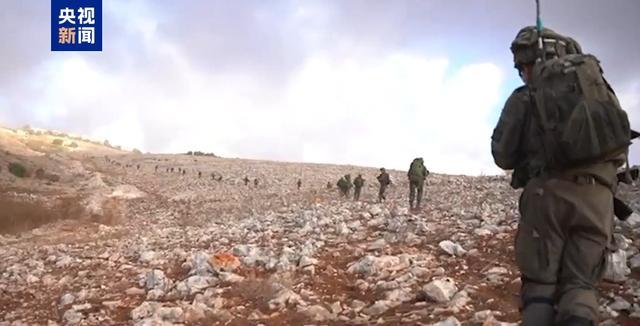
[0,133,640,325]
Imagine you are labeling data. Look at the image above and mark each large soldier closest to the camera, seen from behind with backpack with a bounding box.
[491,26,629,326]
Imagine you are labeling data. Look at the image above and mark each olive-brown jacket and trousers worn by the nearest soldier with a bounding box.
[491,26,624,326]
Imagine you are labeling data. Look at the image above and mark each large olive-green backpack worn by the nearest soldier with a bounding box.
[531,53,631,170]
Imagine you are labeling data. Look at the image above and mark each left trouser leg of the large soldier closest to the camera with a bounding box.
[515,179,564,326]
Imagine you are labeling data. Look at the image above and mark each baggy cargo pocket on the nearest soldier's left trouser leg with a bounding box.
[515,221,553,281]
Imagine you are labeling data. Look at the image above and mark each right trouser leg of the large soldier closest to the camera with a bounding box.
[557,182,614,325]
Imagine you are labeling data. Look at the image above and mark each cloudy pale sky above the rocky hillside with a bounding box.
[0,0,640,175]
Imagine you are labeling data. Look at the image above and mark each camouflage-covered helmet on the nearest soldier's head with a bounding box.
[511,26,582,69]
